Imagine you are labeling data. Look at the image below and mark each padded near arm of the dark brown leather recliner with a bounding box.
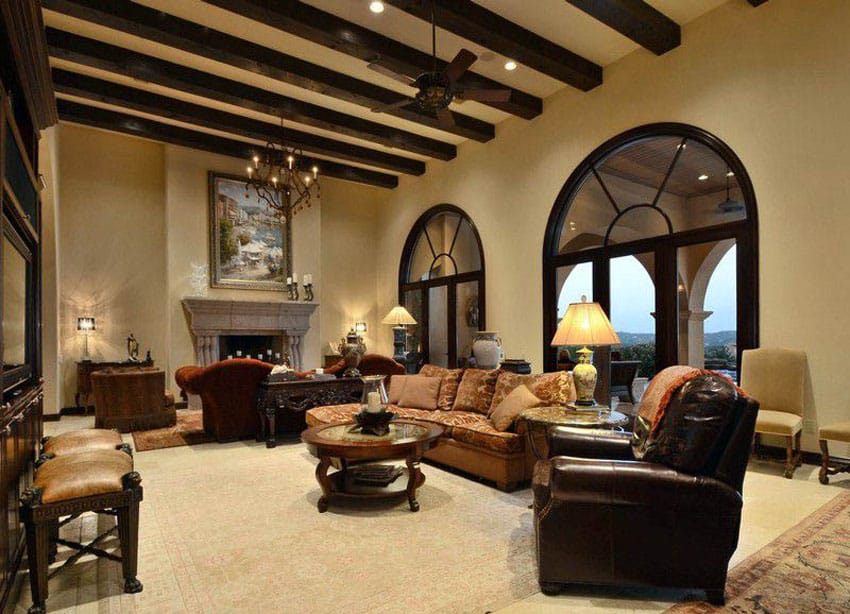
[549,456,742,512]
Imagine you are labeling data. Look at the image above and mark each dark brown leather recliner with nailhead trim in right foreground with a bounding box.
[532,375,758,604]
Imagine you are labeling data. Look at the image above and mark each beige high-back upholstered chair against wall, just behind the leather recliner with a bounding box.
[741,348,806,479]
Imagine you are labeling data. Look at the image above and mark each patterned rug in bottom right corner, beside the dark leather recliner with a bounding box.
[665,492,850,614]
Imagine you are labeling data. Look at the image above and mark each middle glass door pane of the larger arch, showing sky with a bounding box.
[610,252,656,384]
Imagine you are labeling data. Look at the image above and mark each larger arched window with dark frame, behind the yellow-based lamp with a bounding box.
[543,124,758,384]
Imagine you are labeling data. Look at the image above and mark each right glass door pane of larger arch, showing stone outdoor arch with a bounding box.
[677,239,738,379]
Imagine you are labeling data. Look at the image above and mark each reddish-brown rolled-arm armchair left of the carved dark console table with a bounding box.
[174,358,272,442]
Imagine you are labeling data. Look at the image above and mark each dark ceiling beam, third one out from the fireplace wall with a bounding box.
[47,28,457,160]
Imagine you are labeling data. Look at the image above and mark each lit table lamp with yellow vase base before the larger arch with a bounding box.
[551,296,620,406]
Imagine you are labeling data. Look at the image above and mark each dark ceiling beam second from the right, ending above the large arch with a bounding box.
[384,0,602,91]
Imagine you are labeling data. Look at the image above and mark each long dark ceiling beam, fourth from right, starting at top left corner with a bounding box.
[42,0,496,143]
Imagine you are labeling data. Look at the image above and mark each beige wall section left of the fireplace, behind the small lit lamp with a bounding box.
[58,125,168,405]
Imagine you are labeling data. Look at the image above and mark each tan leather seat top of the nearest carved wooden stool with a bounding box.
[33,450,133,503]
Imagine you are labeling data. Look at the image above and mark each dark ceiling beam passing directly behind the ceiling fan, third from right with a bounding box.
[204,0,543,119]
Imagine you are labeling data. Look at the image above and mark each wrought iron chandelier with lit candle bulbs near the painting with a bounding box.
[245,118,321,218]
